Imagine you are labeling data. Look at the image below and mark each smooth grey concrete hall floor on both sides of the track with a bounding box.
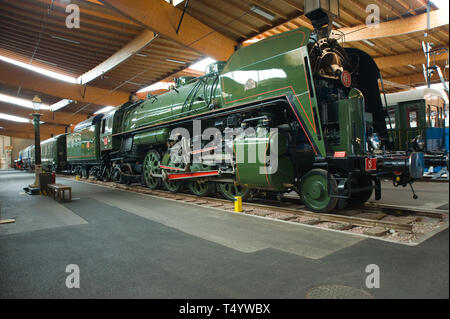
[0,171,449,298]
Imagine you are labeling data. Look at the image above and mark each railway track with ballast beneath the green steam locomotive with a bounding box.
[61,176,448,240]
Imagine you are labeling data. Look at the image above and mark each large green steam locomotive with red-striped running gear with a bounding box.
[19,5,424,212]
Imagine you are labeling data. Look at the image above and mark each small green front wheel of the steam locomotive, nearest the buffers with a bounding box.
[300,169,338,213]
